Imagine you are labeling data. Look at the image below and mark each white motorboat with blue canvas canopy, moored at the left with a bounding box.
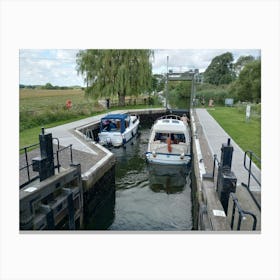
[98,114,140,147]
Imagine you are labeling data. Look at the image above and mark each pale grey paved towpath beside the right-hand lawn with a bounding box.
[196,109,261,191]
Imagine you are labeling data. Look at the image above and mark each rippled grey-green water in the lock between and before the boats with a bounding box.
[108,128,192,231]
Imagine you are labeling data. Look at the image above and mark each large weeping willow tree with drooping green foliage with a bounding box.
[76,49,153,106]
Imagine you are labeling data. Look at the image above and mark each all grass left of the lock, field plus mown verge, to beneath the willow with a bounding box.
[19,89,160,148]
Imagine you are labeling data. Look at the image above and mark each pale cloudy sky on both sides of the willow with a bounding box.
[19,49,260,86]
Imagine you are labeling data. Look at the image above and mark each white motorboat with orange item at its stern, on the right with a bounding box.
[146,115,191,165]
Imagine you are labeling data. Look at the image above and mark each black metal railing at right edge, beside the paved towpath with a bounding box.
[241,151,261,210]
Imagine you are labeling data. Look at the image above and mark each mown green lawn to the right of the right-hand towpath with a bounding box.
[208,107,261,164]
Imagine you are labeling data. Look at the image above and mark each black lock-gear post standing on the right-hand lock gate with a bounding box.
[217,139,237,214]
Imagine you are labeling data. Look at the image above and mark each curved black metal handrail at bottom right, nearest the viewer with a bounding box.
[230,193,257,231]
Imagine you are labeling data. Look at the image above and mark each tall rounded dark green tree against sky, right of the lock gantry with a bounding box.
[204,52,235,85]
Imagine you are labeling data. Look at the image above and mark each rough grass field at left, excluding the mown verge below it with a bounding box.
[20,89,103,132]
